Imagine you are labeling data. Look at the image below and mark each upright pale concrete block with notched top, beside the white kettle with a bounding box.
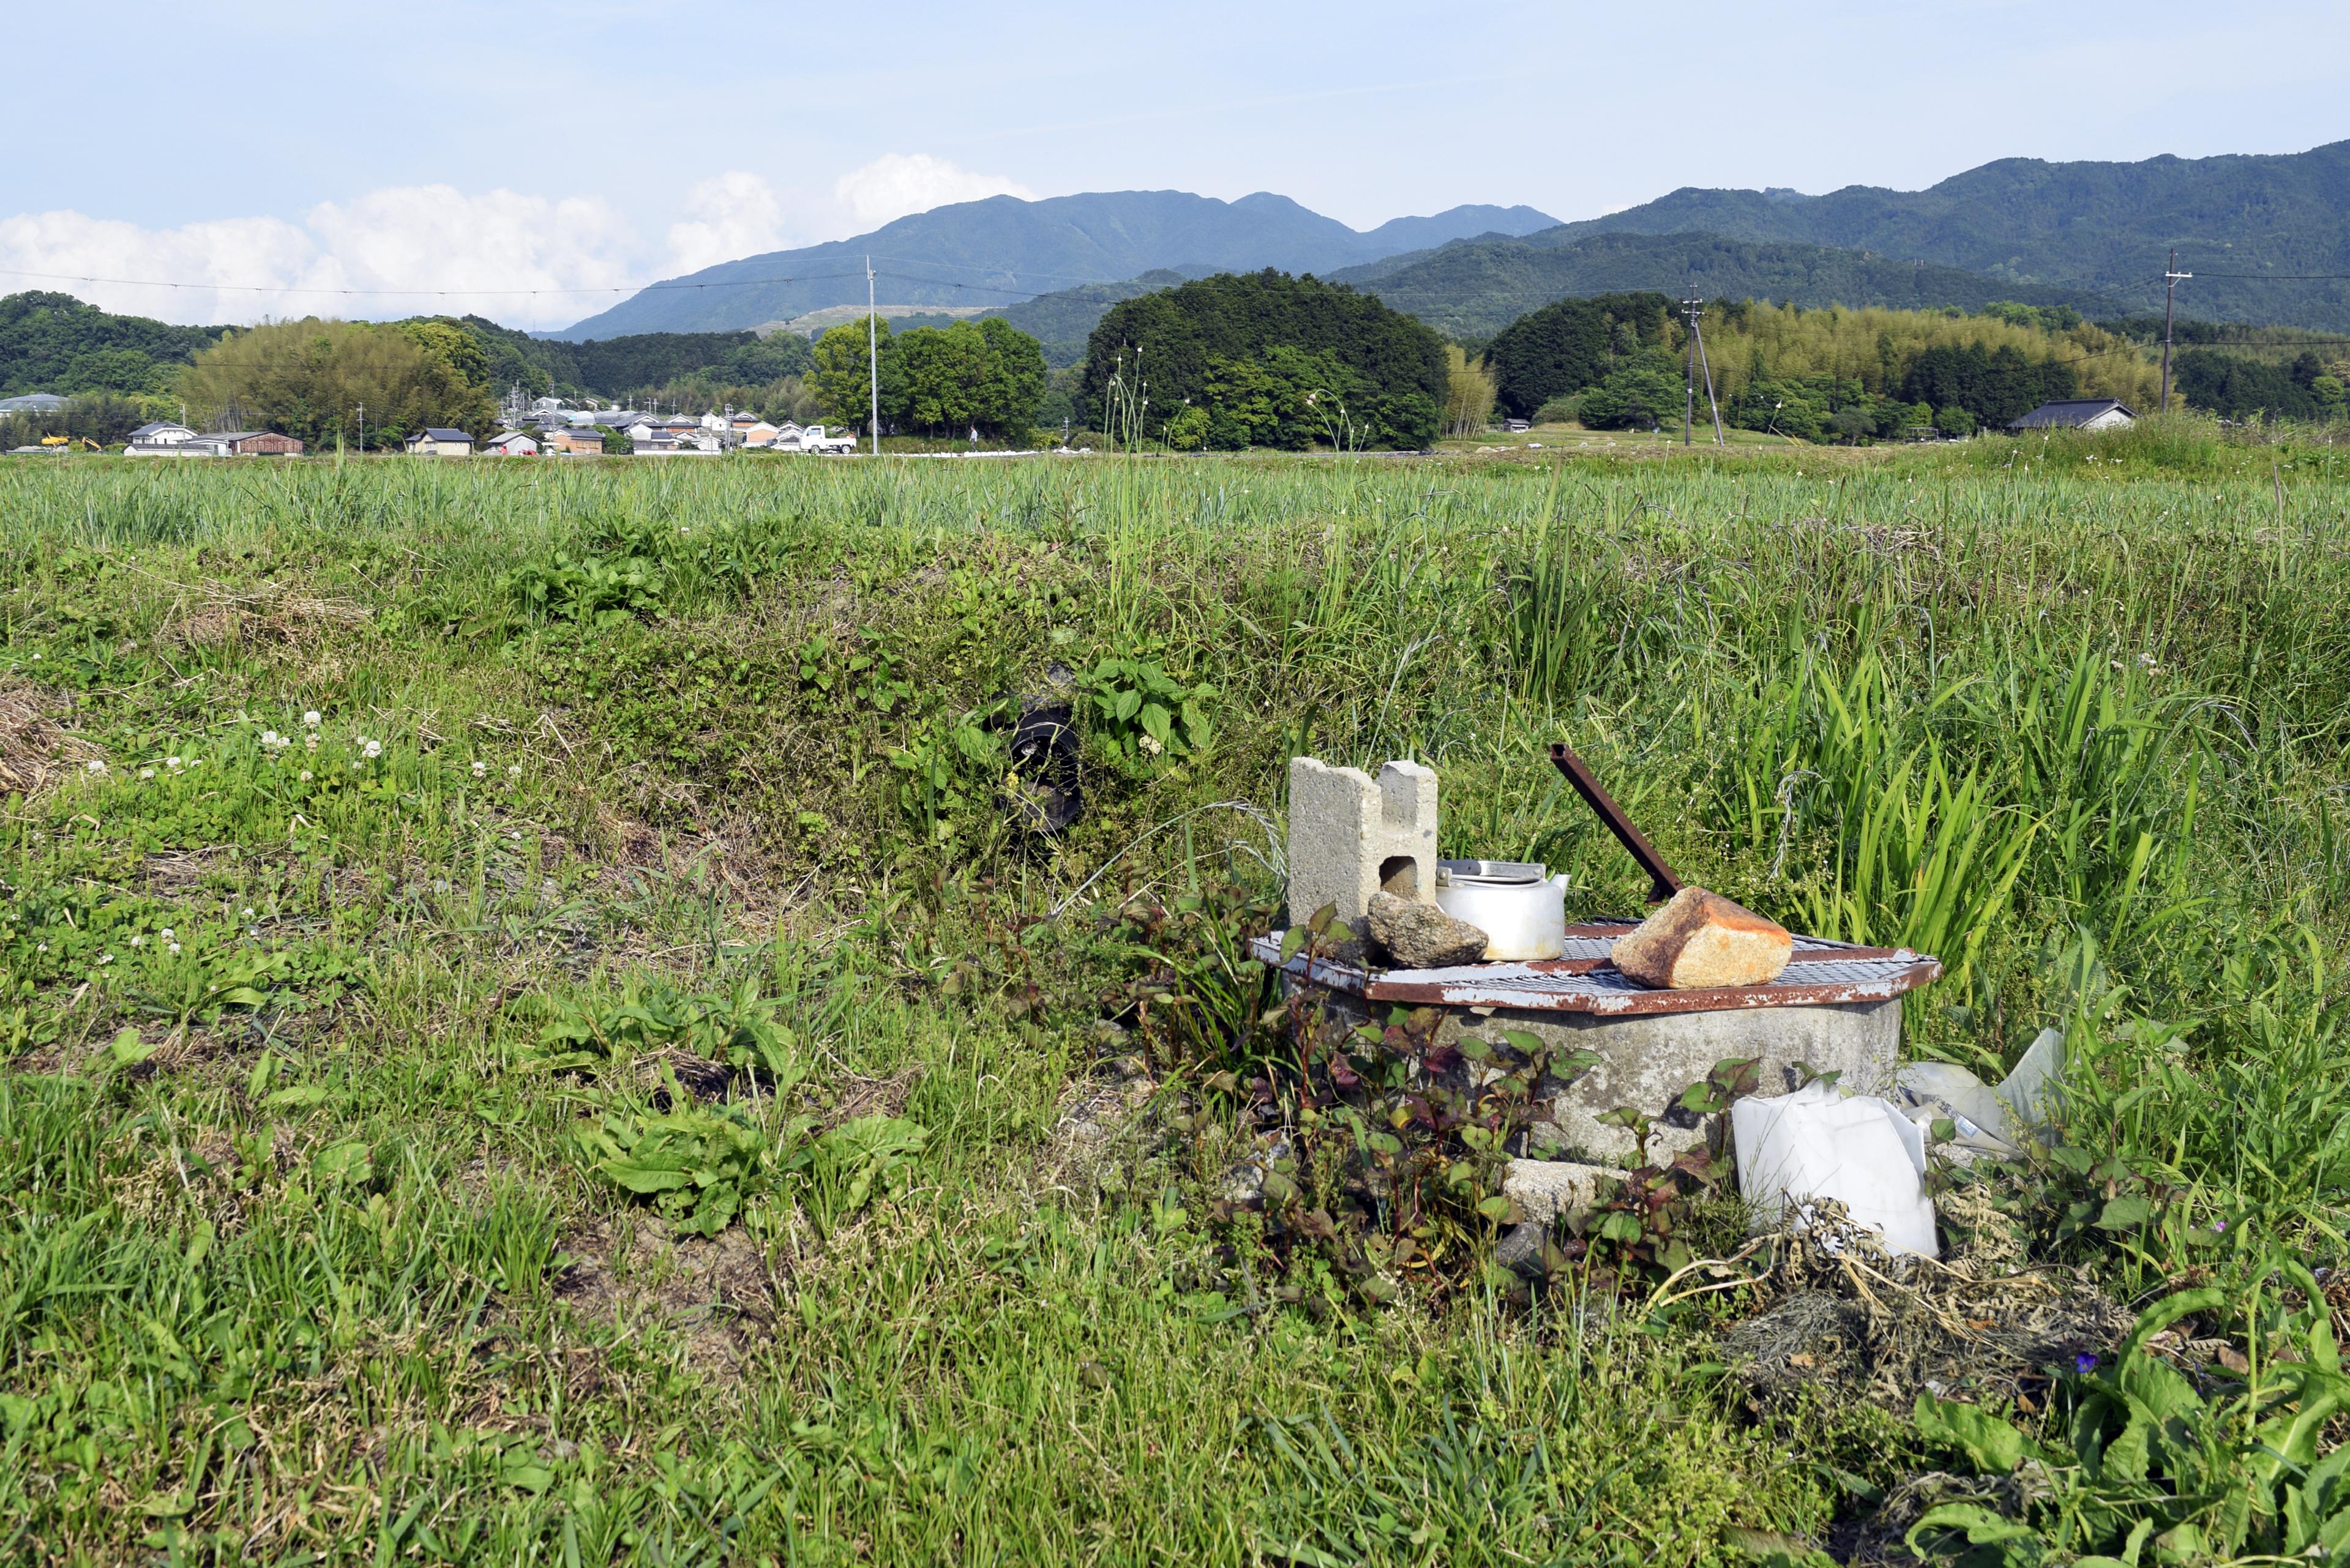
[1290,757,1436,938]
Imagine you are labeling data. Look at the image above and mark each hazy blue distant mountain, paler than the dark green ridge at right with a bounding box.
[547,190,1558,338]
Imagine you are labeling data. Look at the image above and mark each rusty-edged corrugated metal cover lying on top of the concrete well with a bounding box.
[1252,922,1941,1018]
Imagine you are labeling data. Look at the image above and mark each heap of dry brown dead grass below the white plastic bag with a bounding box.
[1687,1190,2131,1415]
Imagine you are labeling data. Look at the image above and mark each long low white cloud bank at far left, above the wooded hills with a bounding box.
[0,185,644,327]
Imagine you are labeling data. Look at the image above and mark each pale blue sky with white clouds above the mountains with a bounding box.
[0,0,2350,327]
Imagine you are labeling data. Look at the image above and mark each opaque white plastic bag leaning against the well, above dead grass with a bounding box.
[1730,1081,1941,1258]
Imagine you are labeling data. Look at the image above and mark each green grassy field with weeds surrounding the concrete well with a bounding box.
[0,425,2350,1563]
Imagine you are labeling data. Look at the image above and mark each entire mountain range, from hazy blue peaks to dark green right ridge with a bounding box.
[552,141,2350,345]
